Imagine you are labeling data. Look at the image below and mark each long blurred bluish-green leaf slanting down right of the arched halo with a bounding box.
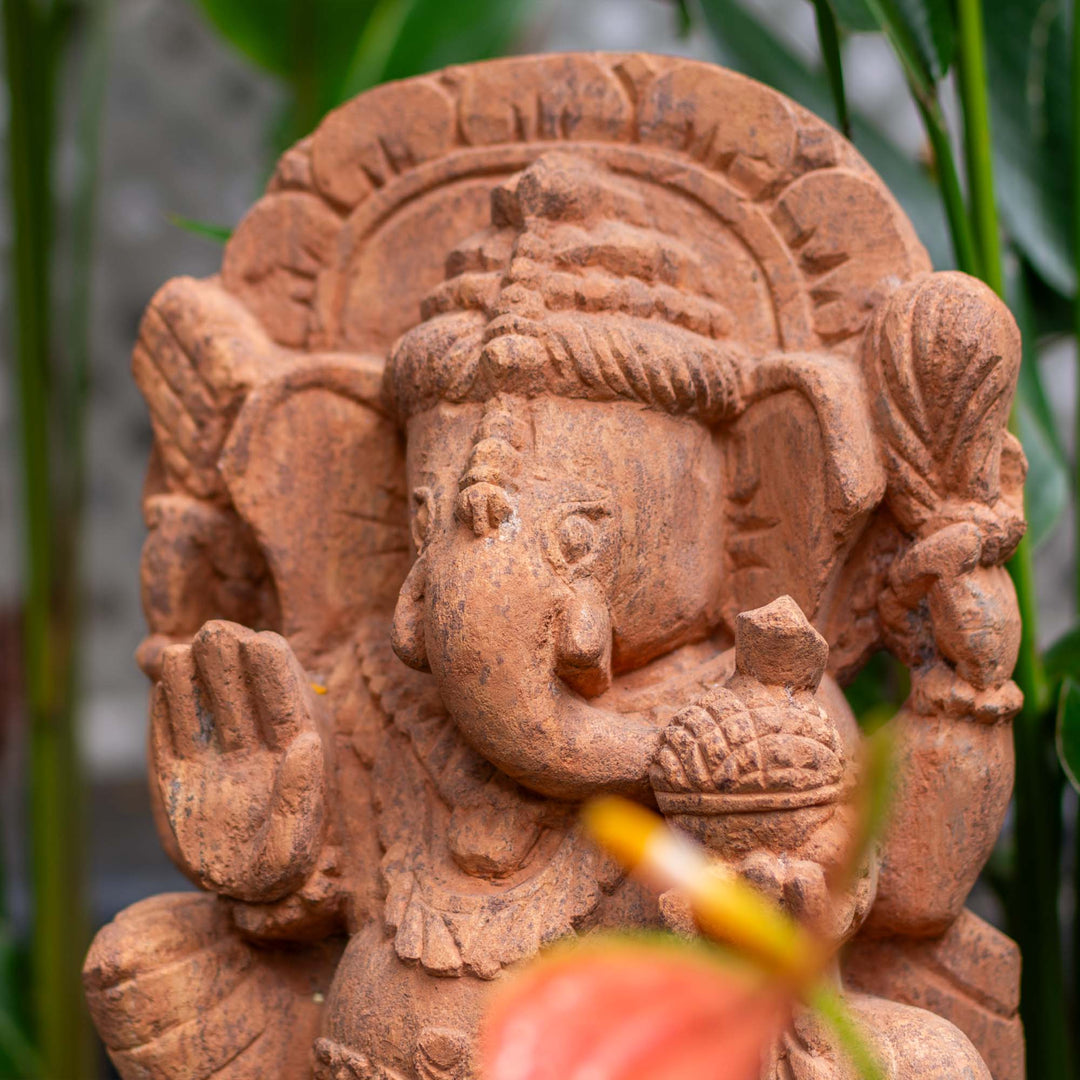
[701,0,955,270]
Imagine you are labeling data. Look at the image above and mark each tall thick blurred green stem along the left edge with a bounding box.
[3,0,93,1080]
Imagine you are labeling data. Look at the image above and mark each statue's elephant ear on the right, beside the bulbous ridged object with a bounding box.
[725,353,886,626]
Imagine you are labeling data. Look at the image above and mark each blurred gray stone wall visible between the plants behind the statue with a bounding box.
[0,0,1072,913]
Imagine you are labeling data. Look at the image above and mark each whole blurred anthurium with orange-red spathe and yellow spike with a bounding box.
[480,794,883,1080]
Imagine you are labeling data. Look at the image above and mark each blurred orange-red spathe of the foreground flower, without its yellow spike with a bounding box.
[481,937,794,1080]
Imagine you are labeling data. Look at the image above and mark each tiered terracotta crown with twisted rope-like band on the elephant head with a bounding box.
[387,152,744,422]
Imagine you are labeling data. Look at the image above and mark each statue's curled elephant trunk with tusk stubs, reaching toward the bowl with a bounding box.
[393,519,659,799]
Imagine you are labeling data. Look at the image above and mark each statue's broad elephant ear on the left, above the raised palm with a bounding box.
[219,355,411,667]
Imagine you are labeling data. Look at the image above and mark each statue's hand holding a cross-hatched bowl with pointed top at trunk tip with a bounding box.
[650,596,876,944]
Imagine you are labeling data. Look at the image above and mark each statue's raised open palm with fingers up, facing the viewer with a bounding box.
[150,621,326,902]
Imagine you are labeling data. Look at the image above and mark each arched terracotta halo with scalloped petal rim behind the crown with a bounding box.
[222,54,930,362]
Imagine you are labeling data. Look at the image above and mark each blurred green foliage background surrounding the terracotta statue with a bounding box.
[0,0,1080,1080]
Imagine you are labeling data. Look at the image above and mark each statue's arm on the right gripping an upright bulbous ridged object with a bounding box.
[864,273,1024,935]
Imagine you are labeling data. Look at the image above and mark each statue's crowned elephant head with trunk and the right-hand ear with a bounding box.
[386,153,898,798]
